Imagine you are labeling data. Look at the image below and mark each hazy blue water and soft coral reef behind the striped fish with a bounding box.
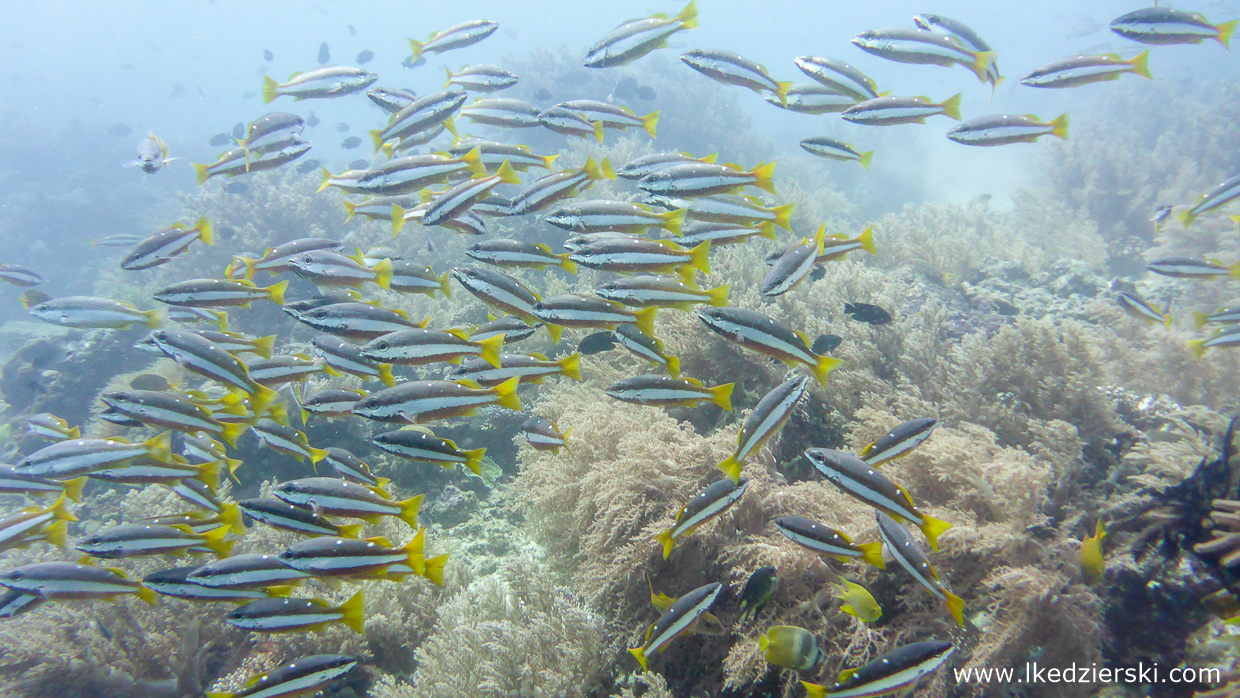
[0,0,1240,698]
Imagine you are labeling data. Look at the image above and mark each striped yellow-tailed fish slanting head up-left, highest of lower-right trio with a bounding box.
[805,449,951,550]
